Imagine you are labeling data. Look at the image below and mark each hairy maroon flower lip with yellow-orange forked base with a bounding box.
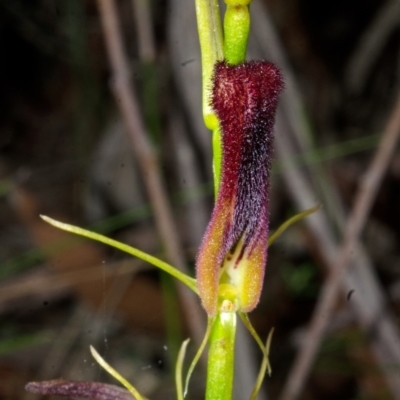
[197,61,283,316]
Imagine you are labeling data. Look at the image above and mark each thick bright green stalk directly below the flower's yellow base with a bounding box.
[206,311,236,400]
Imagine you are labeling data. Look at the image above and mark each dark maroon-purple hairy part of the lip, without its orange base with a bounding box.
[212,61,282,250]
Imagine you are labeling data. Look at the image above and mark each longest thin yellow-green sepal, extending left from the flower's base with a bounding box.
[40,215,198,293]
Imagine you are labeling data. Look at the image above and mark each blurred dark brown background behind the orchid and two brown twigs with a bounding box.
[0,0,400,400]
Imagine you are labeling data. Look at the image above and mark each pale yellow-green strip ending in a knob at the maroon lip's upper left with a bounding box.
[196,0,224,131]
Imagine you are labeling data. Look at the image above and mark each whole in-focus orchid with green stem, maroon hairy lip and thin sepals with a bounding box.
[27,0,319,400]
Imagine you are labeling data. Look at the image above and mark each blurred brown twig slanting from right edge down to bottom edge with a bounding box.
[281,96,400,400]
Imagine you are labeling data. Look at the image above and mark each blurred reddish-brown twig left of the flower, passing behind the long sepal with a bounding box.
[98,0,203,342]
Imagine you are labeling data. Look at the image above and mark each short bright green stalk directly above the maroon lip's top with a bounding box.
[224,0,251,65]
